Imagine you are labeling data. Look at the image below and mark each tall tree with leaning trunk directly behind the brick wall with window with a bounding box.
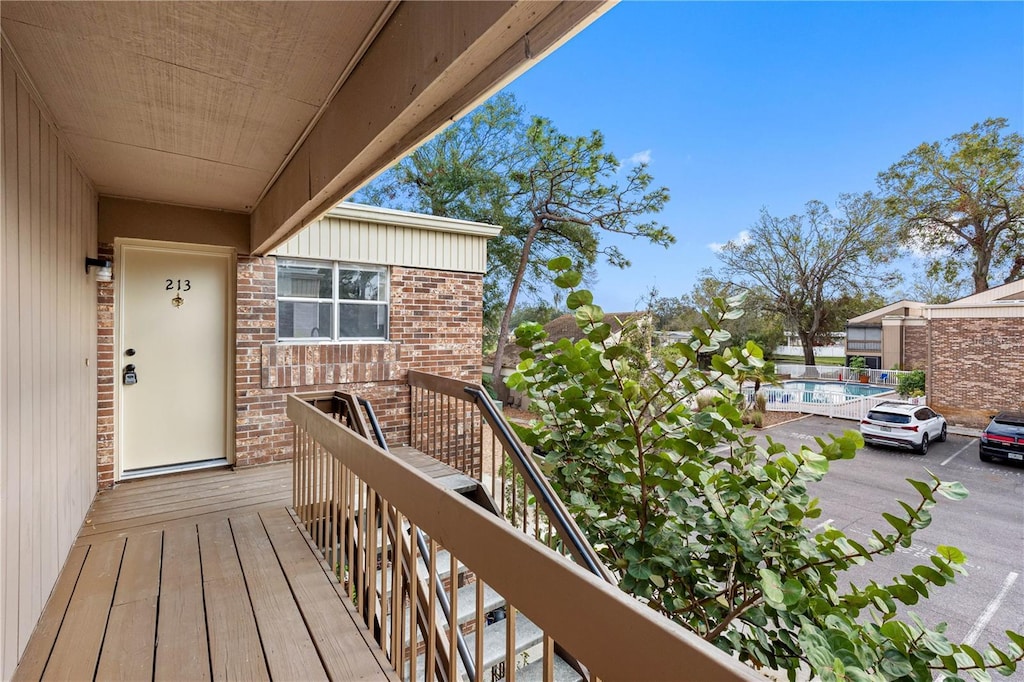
[357,94,674,382]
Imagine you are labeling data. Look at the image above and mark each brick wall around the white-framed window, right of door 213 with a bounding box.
[234,257,483,466]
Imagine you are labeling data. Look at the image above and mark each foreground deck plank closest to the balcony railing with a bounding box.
[260,509,393,680]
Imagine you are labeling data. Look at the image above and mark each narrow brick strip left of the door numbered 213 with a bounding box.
[96,244,115,489]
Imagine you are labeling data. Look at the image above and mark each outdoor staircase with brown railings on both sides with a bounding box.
[287,382,757,682]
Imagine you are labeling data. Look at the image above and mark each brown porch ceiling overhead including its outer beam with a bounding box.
[0,0,609,252]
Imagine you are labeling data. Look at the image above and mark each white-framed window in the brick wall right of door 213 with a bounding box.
[278,258,388,341]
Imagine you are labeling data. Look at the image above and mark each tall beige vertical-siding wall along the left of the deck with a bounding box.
[0,50,96,679]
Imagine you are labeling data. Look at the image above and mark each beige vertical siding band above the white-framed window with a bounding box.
[273,216,487,272]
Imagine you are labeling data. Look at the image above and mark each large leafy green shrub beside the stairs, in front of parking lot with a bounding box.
[510,258,1024,680]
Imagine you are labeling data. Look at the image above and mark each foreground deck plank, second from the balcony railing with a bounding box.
[231,514,328,680]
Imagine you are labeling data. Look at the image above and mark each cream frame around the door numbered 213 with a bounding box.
[111,238,238,482]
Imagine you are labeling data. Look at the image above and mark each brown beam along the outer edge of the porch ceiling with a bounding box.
[250,0,613,254]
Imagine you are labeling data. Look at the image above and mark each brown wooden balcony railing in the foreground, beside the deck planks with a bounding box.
[288,395,759,682]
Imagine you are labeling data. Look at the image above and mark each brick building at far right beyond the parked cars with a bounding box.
[847,280,1024,426]
